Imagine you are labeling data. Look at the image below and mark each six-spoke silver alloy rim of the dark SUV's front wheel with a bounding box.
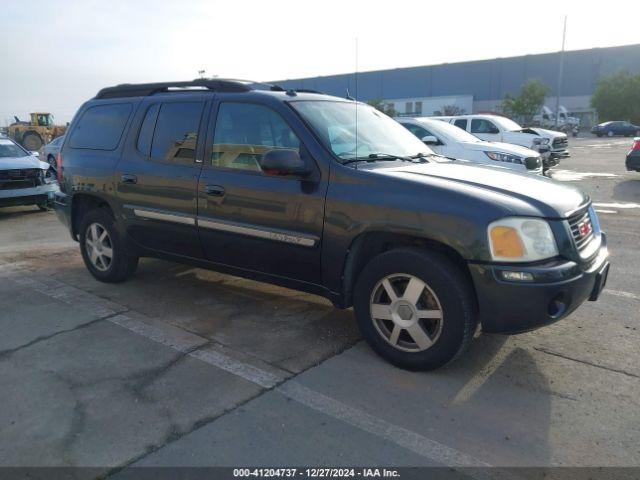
[370,274,443,352]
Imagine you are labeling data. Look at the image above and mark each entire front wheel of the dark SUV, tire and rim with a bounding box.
[354,248,477,370]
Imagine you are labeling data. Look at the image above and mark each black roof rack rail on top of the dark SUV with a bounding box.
[95,78,252,99]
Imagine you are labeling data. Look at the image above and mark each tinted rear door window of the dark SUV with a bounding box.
[150,102,204,161]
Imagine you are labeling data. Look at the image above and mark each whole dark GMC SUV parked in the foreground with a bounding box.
[56,80,609,369]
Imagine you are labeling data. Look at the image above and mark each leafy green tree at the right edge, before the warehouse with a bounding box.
[591,71,640,124]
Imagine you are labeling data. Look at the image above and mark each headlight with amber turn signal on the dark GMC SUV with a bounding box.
[488,217,558,262]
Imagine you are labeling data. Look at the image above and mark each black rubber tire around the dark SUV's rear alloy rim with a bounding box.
[79,208,138,283]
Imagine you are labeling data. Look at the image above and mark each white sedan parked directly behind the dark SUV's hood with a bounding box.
[396,117,542,175]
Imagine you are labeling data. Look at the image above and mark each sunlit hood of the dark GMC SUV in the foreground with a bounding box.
[375,162,589,218]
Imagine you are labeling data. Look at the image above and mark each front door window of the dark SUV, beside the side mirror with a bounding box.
[211,102,300,172]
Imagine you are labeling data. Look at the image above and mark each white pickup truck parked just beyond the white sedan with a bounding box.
[433,115,569,159]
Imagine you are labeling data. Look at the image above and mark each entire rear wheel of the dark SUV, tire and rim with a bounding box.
[80,208,138,283]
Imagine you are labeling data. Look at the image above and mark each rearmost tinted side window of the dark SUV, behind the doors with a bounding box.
[69,103,132,150]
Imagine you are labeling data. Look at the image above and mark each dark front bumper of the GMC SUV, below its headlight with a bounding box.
[469,233,609,333]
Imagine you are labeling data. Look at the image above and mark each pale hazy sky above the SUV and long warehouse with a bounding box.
[0,0,640,125]
